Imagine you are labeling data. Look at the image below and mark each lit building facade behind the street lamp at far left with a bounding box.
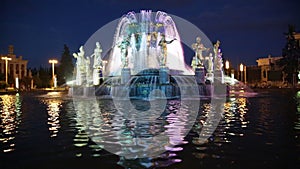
[0,45,28,82]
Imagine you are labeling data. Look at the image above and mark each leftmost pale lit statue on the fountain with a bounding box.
[73,46,86,85]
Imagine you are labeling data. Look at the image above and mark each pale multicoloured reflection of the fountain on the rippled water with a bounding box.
[73,99,189,167]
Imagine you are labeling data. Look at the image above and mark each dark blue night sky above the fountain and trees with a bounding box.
[0,0,300,67]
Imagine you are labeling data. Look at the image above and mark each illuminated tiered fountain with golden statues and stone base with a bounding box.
[72,10,224,99]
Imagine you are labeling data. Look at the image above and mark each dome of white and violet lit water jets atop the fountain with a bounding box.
[105,10,193,76]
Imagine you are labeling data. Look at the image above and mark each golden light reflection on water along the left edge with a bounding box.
[0,93,22,152]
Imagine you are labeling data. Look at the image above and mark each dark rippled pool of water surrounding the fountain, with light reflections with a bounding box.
[0,89,300,169]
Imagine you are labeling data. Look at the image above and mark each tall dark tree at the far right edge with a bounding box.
[279,25,300,84]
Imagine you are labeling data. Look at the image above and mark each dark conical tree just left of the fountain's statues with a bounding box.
[57,45,74,85]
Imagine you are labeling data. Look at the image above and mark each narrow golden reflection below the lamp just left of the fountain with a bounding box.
[43,92,62,137]
